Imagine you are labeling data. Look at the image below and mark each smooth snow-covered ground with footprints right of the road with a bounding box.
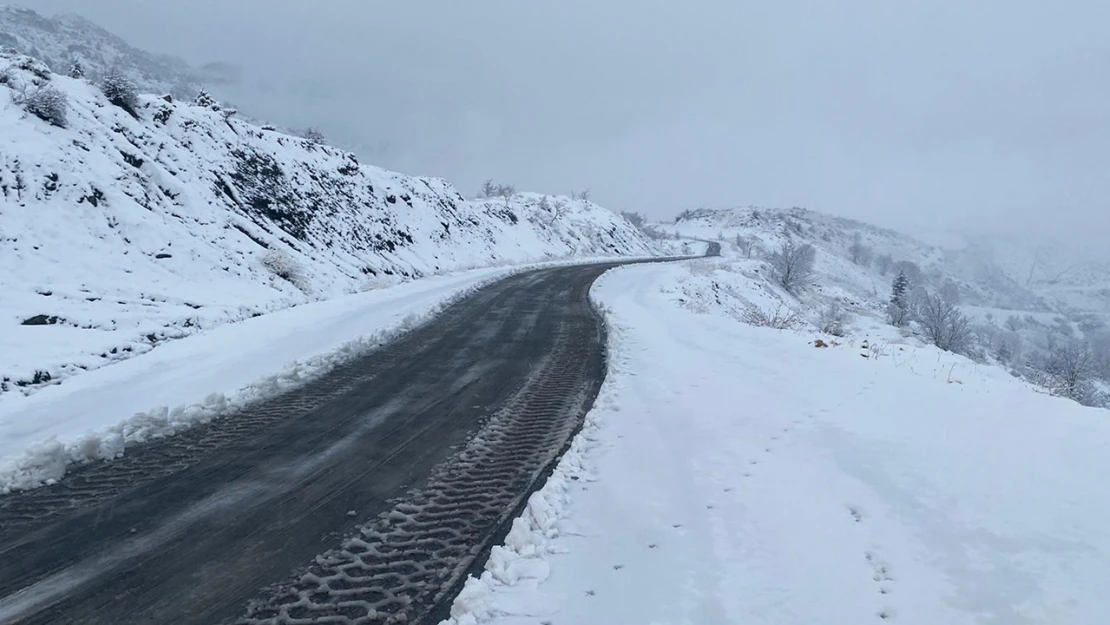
[441,261,1110,625]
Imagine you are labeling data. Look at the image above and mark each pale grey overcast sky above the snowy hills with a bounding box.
[23,0,1110,249]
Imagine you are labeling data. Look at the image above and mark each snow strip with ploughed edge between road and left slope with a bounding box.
[0,258,648,493]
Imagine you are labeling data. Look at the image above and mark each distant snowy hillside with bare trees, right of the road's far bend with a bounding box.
[654,208,1110,404]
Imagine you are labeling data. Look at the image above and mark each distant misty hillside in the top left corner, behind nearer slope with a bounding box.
[0,6,206,97]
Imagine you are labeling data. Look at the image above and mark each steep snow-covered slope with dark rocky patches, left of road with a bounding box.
[0,52,656,396]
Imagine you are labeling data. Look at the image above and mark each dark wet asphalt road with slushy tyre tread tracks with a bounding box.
[0,257,683,625]
